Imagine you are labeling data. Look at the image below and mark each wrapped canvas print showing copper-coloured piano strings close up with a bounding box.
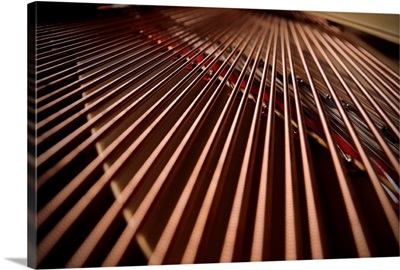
[27,2,400,268]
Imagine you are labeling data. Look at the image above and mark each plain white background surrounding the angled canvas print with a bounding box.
[0,0,400,270]
